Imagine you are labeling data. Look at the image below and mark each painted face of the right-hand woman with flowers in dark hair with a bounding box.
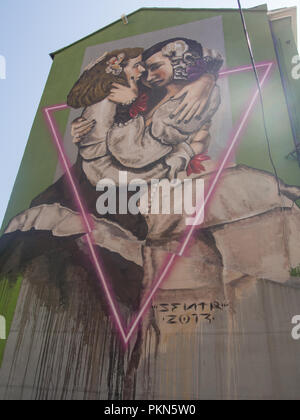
[145,52,174,87]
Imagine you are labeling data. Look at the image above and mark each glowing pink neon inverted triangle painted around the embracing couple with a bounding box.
[43,62,274,345]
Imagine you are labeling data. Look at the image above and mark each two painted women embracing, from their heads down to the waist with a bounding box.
[68,39,223,185]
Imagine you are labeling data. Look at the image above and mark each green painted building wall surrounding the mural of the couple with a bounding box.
[0,6,300,360]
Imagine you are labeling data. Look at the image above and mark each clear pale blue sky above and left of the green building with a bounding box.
[0,0,300,226]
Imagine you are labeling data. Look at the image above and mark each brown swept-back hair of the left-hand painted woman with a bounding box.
[67,48,144,108]
